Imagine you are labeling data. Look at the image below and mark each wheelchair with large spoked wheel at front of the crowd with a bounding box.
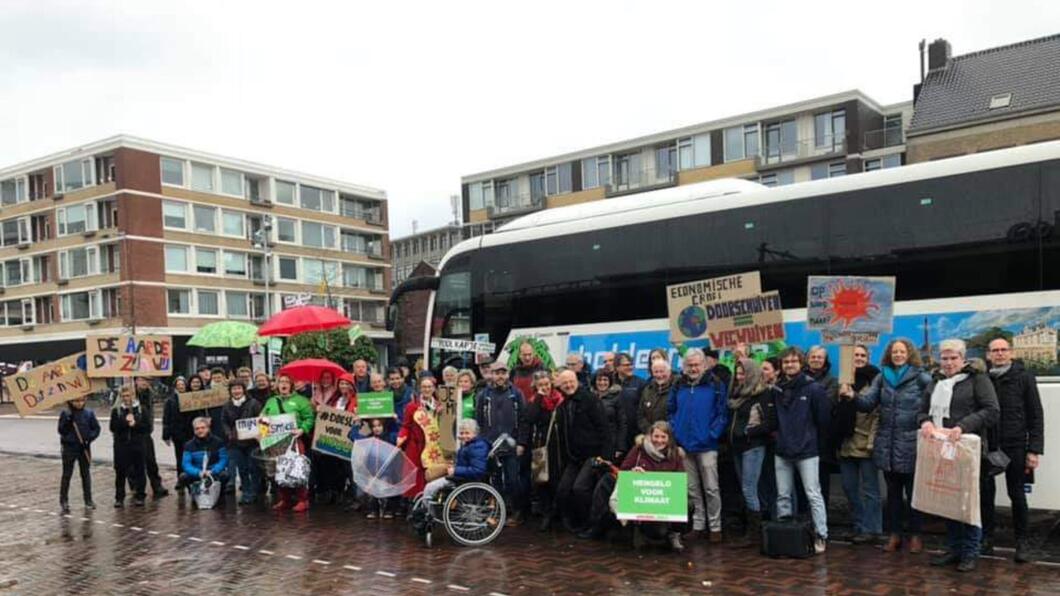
[408,428,514,547]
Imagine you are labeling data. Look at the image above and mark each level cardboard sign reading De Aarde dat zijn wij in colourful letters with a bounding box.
[85,335,173,378]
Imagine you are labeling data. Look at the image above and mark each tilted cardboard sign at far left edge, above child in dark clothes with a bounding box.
[4,352,92,416]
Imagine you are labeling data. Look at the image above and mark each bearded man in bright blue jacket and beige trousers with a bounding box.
[667,348,728,543]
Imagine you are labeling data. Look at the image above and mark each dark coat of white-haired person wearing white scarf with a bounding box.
[917,365,1001,434]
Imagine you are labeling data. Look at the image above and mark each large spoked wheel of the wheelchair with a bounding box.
[442,483,508,546]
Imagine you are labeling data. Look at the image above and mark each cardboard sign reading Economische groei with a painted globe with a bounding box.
[666,271,762,343]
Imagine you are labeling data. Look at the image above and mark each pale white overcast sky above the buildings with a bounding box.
[0,0,1060,236]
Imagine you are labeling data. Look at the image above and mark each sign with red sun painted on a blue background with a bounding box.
[806,276,895,334]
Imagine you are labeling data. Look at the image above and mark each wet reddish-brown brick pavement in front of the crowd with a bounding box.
[0,455,1060,595]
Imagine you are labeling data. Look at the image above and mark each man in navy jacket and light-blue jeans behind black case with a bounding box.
[770,346,832,554]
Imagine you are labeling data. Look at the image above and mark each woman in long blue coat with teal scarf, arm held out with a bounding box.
[840,338,931,553]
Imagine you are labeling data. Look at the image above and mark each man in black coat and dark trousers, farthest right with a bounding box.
[979,337,1045,563]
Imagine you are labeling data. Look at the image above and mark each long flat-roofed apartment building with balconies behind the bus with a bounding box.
[461,90,913,225]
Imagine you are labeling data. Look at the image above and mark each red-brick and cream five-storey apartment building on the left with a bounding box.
[0,136,391,369]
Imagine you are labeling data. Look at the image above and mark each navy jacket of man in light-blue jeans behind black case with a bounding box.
[770,374,832,460]
